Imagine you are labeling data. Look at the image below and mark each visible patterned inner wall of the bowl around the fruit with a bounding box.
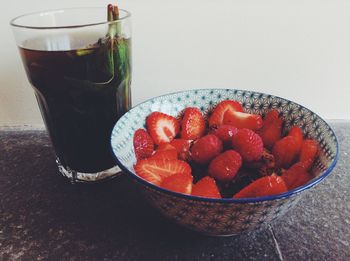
[111,89,338,198]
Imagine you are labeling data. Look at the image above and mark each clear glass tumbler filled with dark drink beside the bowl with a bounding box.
[10,8,131,182]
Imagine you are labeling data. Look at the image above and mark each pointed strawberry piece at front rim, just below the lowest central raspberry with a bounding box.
[192,176,221,198]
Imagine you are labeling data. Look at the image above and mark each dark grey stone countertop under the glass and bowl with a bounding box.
[0,121,350,260]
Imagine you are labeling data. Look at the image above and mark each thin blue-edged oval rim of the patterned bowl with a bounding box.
[110,88,339,203]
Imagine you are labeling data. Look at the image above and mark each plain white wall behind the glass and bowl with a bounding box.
[0,0,350,126]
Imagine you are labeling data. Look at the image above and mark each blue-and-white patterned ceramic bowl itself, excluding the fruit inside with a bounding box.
[111,89,338,236]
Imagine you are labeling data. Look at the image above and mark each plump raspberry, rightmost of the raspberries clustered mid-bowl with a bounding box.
[232,129,264,162]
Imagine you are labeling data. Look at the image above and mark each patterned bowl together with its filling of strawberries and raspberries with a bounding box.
[111,89,338,236]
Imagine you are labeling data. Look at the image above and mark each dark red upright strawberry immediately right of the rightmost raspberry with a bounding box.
[258,110,283,149]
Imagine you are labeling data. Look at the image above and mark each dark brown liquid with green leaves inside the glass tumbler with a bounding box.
[20,35,131,173]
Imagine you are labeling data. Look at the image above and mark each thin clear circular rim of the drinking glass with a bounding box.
[10,7,131,30]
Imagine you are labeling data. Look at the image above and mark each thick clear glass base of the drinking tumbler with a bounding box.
[56,158,122,184]
